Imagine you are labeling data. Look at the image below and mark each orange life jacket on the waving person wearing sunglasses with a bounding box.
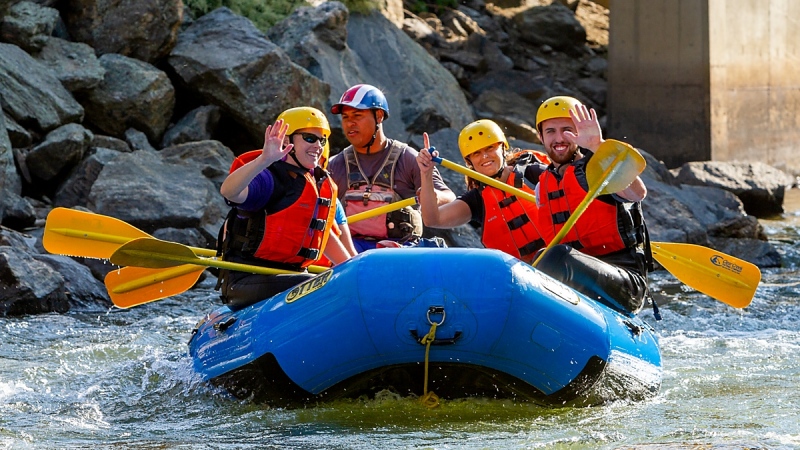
[226,150,337,267]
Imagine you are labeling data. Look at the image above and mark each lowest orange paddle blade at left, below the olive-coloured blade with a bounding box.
[105,264,205,308]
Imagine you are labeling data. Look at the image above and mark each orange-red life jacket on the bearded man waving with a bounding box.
[537,163,643,256]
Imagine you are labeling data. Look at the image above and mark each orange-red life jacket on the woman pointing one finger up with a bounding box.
[481,158,545,263]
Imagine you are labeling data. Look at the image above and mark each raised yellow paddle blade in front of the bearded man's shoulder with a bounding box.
[586,139,647,195]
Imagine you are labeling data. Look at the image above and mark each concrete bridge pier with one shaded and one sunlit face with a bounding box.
[607,0,800,173]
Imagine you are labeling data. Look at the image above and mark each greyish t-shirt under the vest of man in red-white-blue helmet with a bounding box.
[328,139,450,199]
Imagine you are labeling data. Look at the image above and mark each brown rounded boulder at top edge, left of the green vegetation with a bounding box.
[64,0,183,62]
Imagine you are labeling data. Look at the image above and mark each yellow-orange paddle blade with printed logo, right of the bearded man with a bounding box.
[651,242,761,308]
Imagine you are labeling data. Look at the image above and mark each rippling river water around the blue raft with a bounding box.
[0,191,800,449]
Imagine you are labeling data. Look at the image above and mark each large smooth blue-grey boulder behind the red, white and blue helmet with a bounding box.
[270,2,473,141]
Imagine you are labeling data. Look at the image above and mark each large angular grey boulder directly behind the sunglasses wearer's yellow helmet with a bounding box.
[168,8,330,143]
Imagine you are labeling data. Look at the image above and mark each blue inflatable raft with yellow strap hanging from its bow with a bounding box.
[189,248,662,406]
